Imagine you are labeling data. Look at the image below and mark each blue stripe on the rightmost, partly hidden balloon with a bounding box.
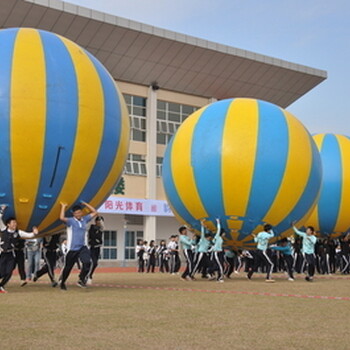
[318,134,343,233]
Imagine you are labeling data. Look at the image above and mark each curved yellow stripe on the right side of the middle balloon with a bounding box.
[263,111,312,224]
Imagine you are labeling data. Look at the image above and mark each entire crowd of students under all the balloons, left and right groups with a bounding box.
[0,202,350,293]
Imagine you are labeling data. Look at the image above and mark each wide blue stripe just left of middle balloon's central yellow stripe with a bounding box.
[191,99,233,218]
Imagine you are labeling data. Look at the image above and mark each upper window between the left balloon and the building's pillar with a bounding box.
[124,95,146,142]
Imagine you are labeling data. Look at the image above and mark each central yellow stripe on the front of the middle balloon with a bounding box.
[221,99,259,229]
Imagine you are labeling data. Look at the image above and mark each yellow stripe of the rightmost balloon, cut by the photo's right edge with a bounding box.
[335,135,350,232]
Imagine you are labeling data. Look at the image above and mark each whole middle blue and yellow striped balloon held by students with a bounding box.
[163,98,322,249]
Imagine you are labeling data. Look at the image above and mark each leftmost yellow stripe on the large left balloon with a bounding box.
[10,29,46,227]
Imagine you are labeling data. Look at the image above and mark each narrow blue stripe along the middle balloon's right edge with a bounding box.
[274,139,322,234]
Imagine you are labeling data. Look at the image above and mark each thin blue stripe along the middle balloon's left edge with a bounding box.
[162,135,199,229]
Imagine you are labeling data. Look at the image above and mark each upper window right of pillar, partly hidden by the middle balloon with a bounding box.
[157,101,197,145]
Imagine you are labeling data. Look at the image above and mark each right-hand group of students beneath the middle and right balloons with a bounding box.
[136,220,350,283]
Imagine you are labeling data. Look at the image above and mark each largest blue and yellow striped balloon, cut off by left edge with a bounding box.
[0,28,129,233]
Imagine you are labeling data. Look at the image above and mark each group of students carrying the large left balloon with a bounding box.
[0,202,104,293]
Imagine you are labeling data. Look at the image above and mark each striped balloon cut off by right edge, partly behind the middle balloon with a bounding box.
[308,134,350,237]
